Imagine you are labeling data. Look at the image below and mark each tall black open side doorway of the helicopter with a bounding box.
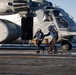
[21,17,33,40]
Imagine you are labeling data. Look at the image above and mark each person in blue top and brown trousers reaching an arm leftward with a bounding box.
[45,25,58,53]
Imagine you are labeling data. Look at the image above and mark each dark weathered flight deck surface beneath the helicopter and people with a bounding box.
[0,49,76,75]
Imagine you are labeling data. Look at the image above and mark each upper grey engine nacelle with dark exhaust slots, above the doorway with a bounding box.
[0,0,31,15]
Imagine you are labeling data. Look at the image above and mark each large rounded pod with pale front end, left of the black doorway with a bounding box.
[0,19,20,42]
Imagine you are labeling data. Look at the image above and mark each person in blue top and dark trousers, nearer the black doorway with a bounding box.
[34,28,44,53]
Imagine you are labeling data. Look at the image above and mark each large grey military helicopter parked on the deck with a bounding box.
[0,0,76,50]
